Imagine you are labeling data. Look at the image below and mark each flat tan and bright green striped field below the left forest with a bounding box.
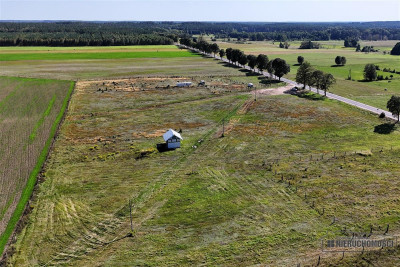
[0,46,244,80]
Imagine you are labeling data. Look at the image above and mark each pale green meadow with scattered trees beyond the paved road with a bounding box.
[219,41,400,109]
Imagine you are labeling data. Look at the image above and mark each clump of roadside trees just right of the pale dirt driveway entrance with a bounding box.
[296,61,336,96]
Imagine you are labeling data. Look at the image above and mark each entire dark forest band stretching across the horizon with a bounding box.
[0,21,400,46]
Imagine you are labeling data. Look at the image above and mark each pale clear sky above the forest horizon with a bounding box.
[0,0,400,22]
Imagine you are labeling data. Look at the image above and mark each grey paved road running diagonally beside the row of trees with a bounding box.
[182,45,397,121]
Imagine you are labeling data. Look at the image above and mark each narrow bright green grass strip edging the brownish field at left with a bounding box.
[0,81,75,264]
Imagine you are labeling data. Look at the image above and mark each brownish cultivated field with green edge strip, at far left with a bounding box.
[0,77,74,253]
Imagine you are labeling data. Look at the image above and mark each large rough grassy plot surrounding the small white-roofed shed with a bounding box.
[9,70,400,266]
